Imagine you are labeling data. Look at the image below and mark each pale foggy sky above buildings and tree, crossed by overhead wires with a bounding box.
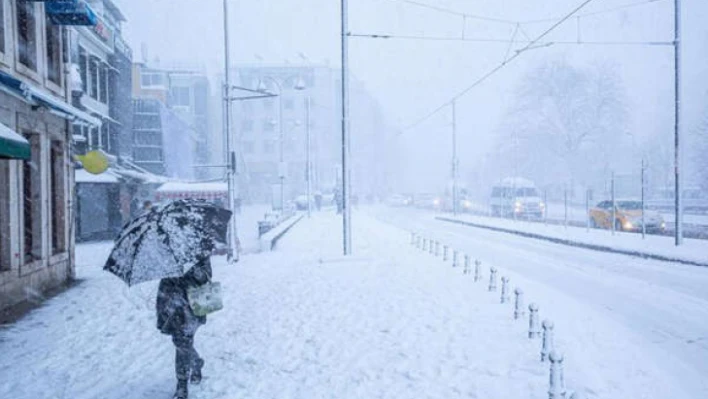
[115,0,708,197]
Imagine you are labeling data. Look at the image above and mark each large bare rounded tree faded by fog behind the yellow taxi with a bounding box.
[498,61,631,193]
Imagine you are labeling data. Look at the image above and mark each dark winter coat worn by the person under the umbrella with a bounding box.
[156,257,211,335]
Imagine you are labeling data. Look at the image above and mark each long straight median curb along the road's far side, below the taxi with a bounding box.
[435,216,708,267]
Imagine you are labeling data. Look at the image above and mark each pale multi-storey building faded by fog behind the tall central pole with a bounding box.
[228,65,390,202]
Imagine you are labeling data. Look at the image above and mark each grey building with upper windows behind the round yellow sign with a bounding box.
[69,0,140,241]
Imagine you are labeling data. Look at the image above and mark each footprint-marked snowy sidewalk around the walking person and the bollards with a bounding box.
[0,214,686,399]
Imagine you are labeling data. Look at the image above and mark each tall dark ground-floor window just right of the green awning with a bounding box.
[22,134,43,263]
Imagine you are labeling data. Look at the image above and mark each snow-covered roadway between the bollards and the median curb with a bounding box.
[369,208,708,398]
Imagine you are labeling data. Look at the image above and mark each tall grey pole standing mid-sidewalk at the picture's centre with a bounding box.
[341,0,352,255]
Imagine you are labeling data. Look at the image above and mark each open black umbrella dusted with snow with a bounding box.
[103,199,231,285]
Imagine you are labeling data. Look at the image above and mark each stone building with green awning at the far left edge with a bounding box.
[0,0,101,309]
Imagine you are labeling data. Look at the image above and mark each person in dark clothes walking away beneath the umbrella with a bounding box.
[156,256,212,399]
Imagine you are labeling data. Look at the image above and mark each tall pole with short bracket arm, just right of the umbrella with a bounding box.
[223,0,239,262]
